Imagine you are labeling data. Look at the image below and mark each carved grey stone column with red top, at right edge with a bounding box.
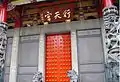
[103,0,120,82]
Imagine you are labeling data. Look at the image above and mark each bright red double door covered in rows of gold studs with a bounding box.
[45,33,72,82]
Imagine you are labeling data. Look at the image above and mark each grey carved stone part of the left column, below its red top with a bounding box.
[0,22,8,82]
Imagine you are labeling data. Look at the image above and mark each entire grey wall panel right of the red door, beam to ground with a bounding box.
[77,29,105,82]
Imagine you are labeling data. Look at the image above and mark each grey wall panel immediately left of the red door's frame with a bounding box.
[16,35,39,82]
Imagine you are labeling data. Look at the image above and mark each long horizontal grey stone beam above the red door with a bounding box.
[8,19,101,37]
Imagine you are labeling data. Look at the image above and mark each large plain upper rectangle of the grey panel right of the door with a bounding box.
[78,36,103,64]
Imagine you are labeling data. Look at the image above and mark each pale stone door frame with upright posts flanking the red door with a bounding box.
[38,30,78,82]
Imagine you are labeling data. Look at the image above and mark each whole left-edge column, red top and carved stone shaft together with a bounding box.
[0,0,8,82]
